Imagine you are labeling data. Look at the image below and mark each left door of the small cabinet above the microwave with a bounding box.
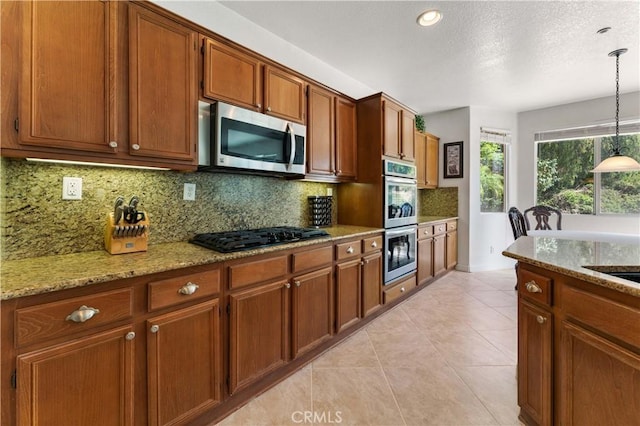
[202,38,262,111]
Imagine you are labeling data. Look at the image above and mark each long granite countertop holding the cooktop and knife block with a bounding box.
[0,225,384,300]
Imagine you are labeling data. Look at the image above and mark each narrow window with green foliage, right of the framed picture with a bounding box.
[480,140,507,213]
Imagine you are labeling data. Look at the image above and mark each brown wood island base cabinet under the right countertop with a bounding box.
[518,260,640,426]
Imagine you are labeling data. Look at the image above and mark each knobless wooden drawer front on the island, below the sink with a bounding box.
[561,285,640,349]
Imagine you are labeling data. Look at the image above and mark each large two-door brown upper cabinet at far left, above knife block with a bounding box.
[1,1,198,170]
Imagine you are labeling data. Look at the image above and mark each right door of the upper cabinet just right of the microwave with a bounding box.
[336,97,358,180]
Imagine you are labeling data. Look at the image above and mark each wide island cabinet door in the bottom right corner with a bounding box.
[556,321,640,426]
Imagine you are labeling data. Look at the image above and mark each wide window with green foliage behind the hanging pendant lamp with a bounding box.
[536,133,640,214]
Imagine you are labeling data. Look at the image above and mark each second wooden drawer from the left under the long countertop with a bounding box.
[149,269,221,311]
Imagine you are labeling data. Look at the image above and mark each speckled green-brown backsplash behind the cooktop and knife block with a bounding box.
[0,158,337,260]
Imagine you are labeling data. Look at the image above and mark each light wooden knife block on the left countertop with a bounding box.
[104,212,149,254]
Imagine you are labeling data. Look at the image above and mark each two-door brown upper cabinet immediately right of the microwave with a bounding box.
[307,85,357,181]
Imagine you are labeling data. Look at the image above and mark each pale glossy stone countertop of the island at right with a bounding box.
[502,236,640,297]
